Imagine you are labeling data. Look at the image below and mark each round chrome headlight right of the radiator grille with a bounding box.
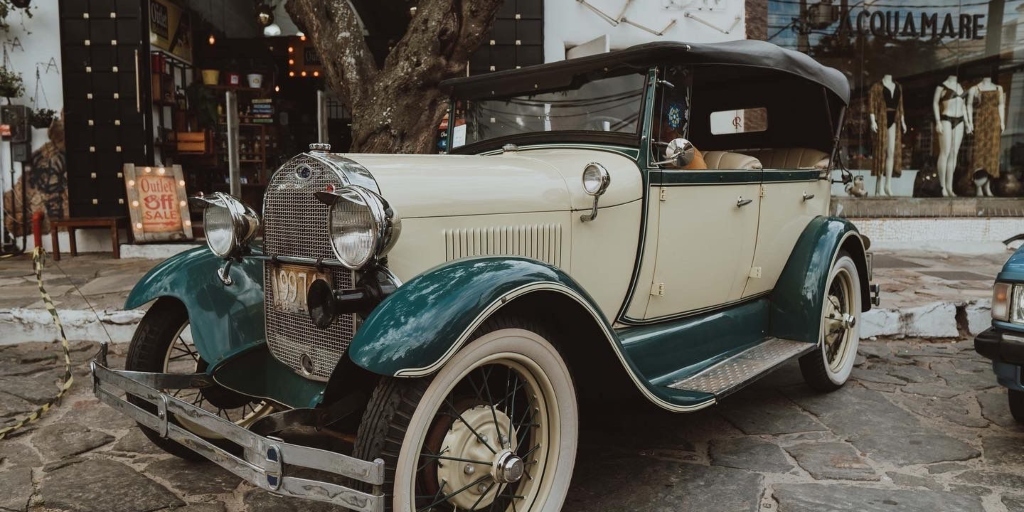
[316,185,401,270]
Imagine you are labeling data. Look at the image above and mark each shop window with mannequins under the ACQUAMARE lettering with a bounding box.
[768,0,1024,197]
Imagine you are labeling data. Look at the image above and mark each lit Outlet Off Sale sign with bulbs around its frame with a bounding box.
[124,164,193,242]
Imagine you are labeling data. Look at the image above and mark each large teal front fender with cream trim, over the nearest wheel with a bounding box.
[348,257,610,377]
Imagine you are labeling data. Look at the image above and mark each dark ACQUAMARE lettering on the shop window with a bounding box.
[839,9,985,39]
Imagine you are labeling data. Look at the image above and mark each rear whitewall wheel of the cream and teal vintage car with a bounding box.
[800,251,861,392]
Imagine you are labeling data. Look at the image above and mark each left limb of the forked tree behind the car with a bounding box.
[286,0,378,106]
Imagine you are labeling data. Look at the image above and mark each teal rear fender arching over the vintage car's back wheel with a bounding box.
[770,217,871,343]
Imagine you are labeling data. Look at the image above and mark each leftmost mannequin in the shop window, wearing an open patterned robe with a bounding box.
[867,75,906,196]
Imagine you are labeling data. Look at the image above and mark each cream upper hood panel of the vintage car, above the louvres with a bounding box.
[344,154,571,218]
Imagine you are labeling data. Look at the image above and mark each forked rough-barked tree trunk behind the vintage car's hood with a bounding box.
[287,0,504,153]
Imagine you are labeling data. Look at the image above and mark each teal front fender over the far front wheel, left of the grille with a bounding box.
[125,247,266,371]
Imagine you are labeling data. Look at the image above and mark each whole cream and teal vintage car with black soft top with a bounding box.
[93,41,878,512]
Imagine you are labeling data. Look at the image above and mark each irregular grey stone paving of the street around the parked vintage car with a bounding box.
[0,340,1024,512]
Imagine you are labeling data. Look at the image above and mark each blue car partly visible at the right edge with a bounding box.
[974,241,1024,424]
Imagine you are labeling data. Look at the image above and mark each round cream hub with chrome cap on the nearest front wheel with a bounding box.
[437,406,525,510]
